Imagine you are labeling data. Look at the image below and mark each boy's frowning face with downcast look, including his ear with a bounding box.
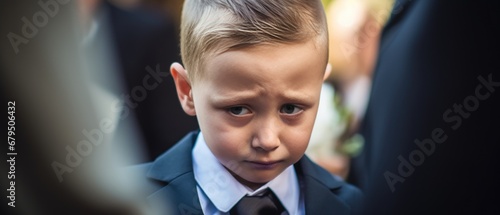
[171,41,326,189]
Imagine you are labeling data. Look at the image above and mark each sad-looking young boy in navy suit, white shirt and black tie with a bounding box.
[139,0,361,215]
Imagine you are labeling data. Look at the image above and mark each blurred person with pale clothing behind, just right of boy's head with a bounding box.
[328,0,392,128]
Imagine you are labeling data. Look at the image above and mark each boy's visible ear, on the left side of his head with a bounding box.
[170,63,196,116]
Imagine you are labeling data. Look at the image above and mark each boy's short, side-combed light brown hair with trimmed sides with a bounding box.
[181,0,328,84]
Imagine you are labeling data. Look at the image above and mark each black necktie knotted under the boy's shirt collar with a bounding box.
[229,188,285,215]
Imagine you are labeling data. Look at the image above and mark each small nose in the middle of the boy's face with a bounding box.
[252,120,281,151]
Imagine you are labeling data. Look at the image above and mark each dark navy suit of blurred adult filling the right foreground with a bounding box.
[350,0,500,214]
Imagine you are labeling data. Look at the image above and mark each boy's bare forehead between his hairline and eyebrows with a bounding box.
[200,41,327,84]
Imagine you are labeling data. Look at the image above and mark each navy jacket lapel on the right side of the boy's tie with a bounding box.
[295,156,351,215]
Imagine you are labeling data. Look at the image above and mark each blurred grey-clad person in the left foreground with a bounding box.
[0,0,158,214]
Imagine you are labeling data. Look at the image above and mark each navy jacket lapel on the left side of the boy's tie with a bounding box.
[147,132,202,214]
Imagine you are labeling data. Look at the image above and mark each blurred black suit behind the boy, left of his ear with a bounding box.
[101,1,198,160]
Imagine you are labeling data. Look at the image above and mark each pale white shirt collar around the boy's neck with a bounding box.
[192,132,300,214]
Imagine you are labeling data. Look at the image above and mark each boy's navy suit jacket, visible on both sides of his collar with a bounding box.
[136,132,362,215]
